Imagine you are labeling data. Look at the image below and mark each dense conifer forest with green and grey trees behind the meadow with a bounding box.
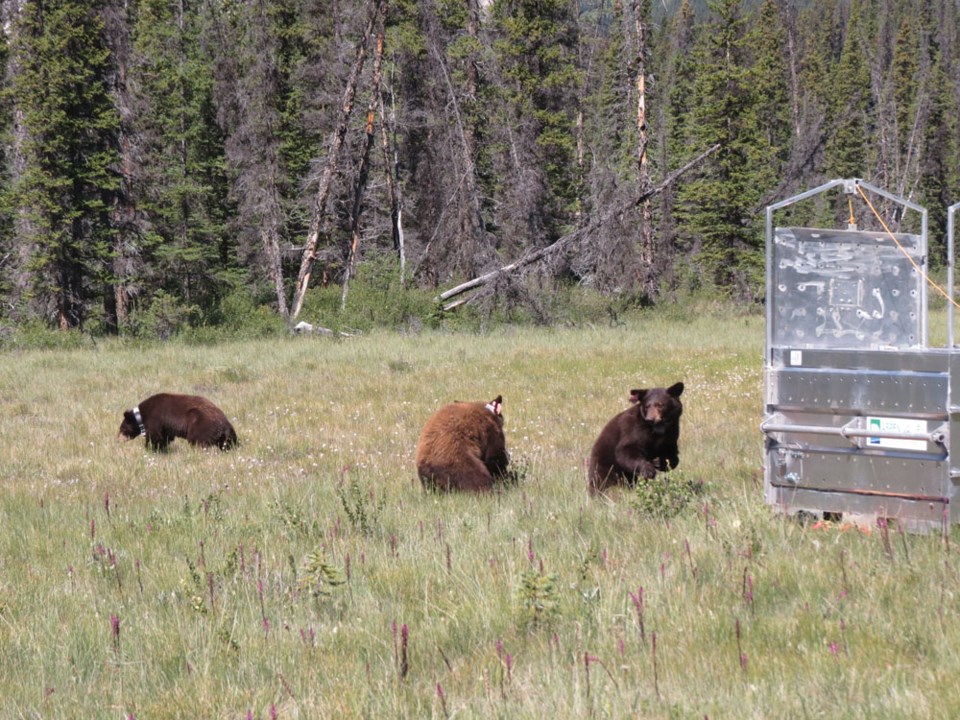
[0,0,960,334]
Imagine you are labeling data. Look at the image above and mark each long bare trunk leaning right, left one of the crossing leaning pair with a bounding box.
[290,0,386,320]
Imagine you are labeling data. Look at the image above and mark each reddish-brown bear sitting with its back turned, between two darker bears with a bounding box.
[416,395,509,492]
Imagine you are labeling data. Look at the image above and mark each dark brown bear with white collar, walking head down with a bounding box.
[120,393,237,450]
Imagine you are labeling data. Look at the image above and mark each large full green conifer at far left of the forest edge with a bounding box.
[13,0,118,329]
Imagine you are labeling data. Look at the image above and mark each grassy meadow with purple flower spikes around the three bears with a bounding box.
[0,313,960,720]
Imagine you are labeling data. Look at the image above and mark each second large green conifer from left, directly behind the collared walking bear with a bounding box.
[131,0,233,329]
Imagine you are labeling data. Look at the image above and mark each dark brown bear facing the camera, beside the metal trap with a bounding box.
[590,382,683,493]
